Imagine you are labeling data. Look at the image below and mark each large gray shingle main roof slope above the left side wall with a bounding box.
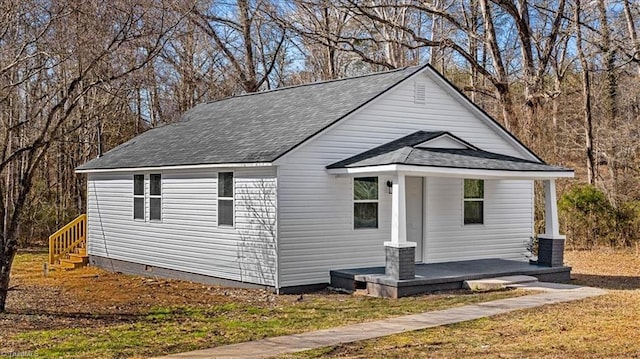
[77,66,424,170]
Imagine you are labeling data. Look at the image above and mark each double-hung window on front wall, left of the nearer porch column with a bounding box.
[353,177,378,229]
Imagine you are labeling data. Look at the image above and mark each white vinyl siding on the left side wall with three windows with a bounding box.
[87,168,276,286]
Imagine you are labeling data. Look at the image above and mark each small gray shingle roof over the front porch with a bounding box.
[327,131,571,172]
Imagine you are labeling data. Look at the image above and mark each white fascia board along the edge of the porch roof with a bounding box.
[327,165,574,179]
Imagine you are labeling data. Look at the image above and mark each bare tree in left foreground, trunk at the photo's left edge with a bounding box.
[0,0,182,312]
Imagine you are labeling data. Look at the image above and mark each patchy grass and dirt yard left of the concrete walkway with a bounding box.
[0,252,524,358]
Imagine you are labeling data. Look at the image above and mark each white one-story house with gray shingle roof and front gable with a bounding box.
[77,66,573,298]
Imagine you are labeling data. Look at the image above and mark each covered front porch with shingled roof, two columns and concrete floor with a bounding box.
[327,131,573,297]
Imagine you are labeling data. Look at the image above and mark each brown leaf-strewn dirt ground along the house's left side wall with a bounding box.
[0,250,290,338]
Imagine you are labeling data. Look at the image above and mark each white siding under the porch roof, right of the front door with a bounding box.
[425,177,533,263]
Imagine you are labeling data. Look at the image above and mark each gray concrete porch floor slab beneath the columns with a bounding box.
[330,258,571,298]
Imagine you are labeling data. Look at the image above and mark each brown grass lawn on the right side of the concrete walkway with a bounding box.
[282,250,640,358]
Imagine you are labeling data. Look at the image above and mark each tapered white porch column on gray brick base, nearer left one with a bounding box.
[384,173,416,280]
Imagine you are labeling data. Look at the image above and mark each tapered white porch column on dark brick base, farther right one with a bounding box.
[538,179,566,267]
